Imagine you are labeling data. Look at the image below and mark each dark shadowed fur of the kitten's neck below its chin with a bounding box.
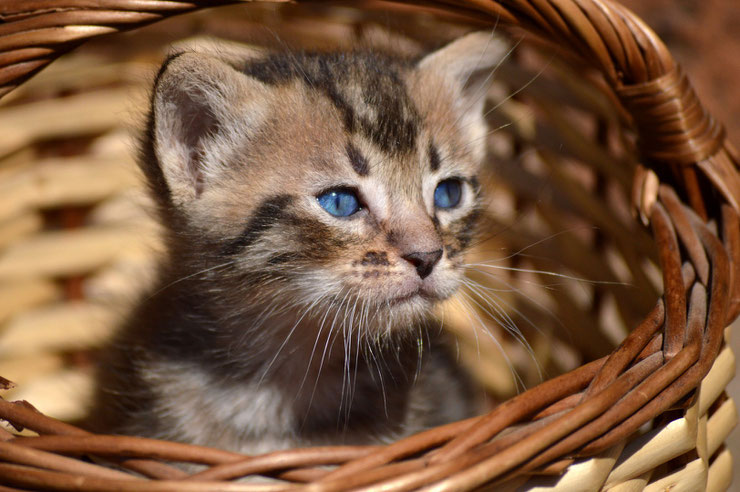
[144,276,422,435]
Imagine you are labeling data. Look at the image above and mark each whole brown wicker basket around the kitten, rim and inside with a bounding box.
[0,0,740,491]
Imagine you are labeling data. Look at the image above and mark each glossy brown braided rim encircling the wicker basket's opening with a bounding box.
[0,0,740,491]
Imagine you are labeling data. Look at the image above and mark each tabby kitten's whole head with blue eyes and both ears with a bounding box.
[143,33,505,334]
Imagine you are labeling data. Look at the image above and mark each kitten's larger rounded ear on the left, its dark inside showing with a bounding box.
[152,48,266,205]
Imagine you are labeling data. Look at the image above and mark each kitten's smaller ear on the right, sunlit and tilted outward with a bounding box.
[418,31,509,114]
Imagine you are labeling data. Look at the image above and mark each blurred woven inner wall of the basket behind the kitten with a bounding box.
[0,1,661,420]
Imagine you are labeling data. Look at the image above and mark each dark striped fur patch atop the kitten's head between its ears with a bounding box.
[244,53,421,157]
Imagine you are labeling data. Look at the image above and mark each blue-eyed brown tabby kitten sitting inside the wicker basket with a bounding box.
[93,33,506,453]
